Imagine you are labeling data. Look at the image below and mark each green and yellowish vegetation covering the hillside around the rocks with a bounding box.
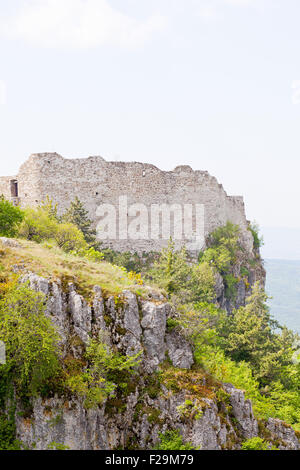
[0,199,300,449]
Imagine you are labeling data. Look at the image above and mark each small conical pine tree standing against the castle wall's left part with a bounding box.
[62,196,99,248]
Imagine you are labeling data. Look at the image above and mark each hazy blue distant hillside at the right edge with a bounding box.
[265,259,300,333]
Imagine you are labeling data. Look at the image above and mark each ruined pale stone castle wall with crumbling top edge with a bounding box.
[0,154,252,252]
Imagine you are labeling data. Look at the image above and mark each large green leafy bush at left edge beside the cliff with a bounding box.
[0,285,59,397]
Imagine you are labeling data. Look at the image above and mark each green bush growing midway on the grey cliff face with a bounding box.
[67,338,140,409]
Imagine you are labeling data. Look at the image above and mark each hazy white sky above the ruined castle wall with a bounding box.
[0,0,300,228]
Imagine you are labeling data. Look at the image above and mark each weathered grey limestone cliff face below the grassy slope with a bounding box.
[16,273,300,450]
